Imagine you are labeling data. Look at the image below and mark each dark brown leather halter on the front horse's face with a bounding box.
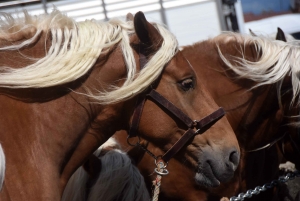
[127,46,225,163]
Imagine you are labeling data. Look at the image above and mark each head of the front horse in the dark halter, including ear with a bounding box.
[123,13,239,186]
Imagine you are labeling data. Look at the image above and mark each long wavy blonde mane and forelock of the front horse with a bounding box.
[0,10,177,104]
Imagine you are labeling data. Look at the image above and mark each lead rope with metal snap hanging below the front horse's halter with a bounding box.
[152,160,169,201]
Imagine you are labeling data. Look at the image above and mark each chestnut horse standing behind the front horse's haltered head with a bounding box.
[69,30,300,201]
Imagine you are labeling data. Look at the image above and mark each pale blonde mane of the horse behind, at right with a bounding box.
[213,33,300,101]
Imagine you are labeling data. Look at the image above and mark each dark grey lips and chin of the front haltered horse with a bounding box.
[195,163,220,187]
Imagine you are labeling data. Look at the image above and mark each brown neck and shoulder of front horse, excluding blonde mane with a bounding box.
[0,33,132,200]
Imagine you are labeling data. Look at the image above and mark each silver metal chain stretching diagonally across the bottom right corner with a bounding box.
[230,170,300,201]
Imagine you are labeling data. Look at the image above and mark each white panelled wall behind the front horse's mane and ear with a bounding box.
[0,0,221,45]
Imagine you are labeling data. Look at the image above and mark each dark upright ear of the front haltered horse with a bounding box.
[134,12,162,48]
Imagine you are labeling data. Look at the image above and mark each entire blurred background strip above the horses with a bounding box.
[0,0,300,45]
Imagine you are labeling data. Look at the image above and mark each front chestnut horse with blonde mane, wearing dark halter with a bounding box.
[0,10,240,201]
